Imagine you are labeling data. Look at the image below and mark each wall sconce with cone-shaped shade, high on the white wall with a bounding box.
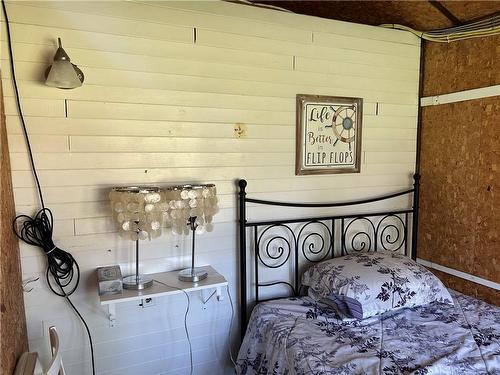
[45,38,84,89]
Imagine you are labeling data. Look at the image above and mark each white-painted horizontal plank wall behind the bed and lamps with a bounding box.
[1,1,420,375]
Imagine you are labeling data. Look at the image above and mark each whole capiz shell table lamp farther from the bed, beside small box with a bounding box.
[109,186,165,290]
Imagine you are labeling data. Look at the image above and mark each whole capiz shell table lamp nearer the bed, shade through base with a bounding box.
[164,184,219,283]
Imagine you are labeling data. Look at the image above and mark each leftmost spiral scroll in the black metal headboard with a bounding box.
[257,224,296,268]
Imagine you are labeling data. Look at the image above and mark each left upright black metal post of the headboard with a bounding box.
[238,179,247,340]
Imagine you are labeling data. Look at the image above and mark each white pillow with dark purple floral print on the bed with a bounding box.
[302,251,453,319]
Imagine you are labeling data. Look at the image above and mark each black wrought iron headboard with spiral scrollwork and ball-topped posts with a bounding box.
[238,174,420,339]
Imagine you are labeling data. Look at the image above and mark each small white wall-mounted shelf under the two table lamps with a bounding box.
[99,266,227,327]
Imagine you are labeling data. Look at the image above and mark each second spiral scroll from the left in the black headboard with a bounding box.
[297,220,333,263]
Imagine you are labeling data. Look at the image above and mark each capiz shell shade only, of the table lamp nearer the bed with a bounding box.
[164,184,219,235]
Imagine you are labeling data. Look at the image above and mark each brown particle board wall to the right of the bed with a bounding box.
[418,37,500,304]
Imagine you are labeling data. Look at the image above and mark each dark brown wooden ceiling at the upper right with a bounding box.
[252,0,500,31]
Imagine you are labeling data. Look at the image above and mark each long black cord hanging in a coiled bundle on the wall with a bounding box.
[2,0,95,375]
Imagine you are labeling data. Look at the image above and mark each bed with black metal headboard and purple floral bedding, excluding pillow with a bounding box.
[236,175,500,375]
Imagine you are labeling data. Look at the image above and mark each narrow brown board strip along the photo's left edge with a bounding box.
[0,75,28,374]
